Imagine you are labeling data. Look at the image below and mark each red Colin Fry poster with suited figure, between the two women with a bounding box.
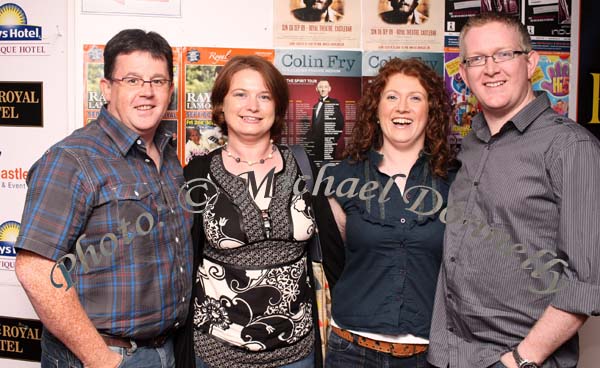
[275,49,362,165]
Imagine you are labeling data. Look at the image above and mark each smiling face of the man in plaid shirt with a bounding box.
[100,51,173,142]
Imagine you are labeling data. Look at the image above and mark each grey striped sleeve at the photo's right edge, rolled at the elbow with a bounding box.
[550,139,600,316]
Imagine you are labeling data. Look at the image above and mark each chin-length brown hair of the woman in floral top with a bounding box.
[210,55,290,141]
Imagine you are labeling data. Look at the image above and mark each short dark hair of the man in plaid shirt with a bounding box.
[104,29,173,81]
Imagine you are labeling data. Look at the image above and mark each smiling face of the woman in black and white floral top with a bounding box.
[223,69,275,140]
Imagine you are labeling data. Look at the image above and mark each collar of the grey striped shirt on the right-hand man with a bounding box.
[471,91,550,142]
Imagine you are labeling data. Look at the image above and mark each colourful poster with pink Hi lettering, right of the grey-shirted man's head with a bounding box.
[531,53,571,116]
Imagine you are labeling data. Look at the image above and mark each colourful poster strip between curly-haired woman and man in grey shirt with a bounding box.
[444,51,480,146]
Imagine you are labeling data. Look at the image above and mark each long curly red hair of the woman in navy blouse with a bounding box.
[344,58,454,178]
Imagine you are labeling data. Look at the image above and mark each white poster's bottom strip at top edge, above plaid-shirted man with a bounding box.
[81,0,181,17]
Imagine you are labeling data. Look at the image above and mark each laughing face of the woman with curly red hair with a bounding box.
[377,73,429,149]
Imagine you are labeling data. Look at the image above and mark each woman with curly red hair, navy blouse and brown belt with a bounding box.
[325,59,455,368]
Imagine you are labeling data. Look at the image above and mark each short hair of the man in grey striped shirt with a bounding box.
[458,12,532,61]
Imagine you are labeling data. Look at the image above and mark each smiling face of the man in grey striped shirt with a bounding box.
[460,22,539,122]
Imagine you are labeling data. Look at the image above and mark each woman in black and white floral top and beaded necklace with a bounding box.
[178,56,342,368]
